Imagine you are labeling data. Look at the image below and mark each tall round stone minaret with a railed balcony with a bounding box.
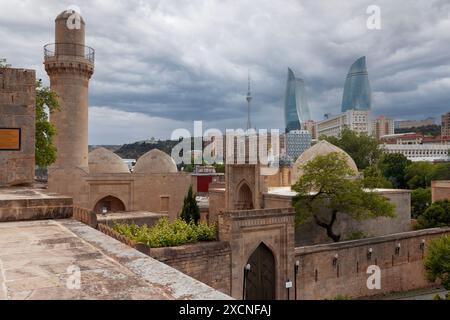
[44,10,94,202]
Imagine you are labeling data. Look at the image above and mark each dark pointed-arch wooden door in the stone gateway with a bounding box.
[244,243,275,300]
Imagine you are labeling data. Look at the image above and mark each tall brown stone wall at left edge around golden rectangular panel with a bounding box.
[0,68,36,186]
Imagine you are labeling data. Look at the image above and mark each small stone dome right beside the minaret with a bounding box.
[88,148,130,174]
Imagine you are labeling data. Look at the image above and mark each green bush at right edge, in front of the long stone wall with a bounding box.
[424,235,450,290]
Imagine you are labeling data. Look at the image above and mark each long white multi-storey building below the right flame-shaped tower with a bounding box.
[317,110,372,137]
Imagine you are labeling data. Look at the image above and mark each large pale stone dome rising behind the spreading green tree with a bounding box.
[292,140,358,184]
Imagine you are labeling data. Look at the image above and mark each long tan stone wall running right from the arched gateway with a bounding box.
[291,228,450,300]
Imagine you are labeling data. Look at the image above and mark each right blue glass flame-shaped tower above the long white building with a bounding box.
[342,57,372,112]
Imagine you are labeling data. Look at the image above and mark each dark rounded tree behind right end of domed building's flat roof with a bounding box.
[378,153,411,188]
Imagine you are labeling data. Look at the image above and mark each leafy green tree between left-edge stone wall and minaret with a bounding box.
[35,80,59,167]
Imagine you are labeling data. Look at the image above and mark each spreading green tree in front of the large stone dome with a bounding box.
[292,152,395,242]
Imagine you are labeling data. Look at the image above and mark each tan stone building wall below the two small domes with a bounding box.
[49,172,191,220]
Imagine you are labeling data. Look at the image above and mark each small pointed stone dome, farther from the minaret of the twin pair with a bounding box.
[133,149,178,173]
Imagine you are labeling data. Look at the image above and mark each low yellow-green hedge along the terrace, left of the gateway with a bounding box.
[113,218,217,248]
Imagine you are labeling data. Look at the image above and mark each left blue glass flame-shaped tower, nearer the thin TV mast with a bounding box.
[284,68,311,132]
